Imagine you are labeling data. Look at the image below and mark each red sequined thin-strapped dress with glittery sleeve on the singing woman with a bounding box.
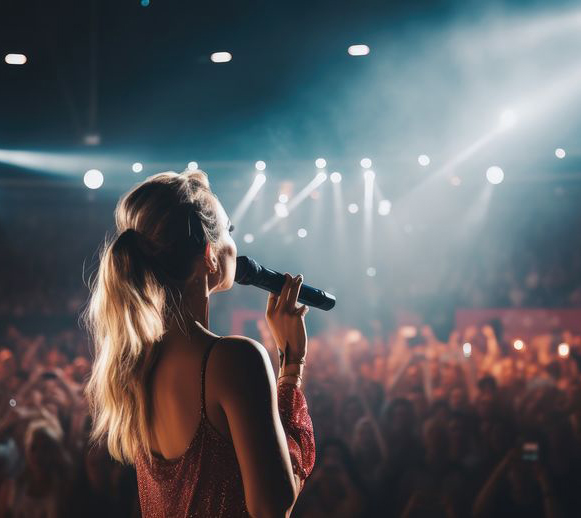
[135,338,315,518]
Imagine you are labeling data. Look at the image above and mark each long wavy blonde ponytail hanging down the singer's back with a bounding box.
[84,229,167,463]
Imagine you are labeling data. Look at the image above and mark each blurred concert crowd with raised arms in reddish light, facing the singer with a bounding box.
[0,317,581,518]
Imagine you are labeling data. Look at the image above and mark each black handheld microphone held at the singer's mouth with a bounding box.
[234,255,336,311]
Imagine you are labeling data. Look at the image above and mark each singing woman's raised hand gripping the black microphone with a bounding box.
[266,273,309,362]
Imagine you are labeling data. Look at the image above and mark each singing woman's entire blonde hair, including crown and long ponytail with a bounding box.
[82,171,221,464]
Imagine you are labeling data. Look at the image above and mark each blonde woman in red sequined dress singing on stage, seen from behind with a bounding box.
[84,171,315,517]
